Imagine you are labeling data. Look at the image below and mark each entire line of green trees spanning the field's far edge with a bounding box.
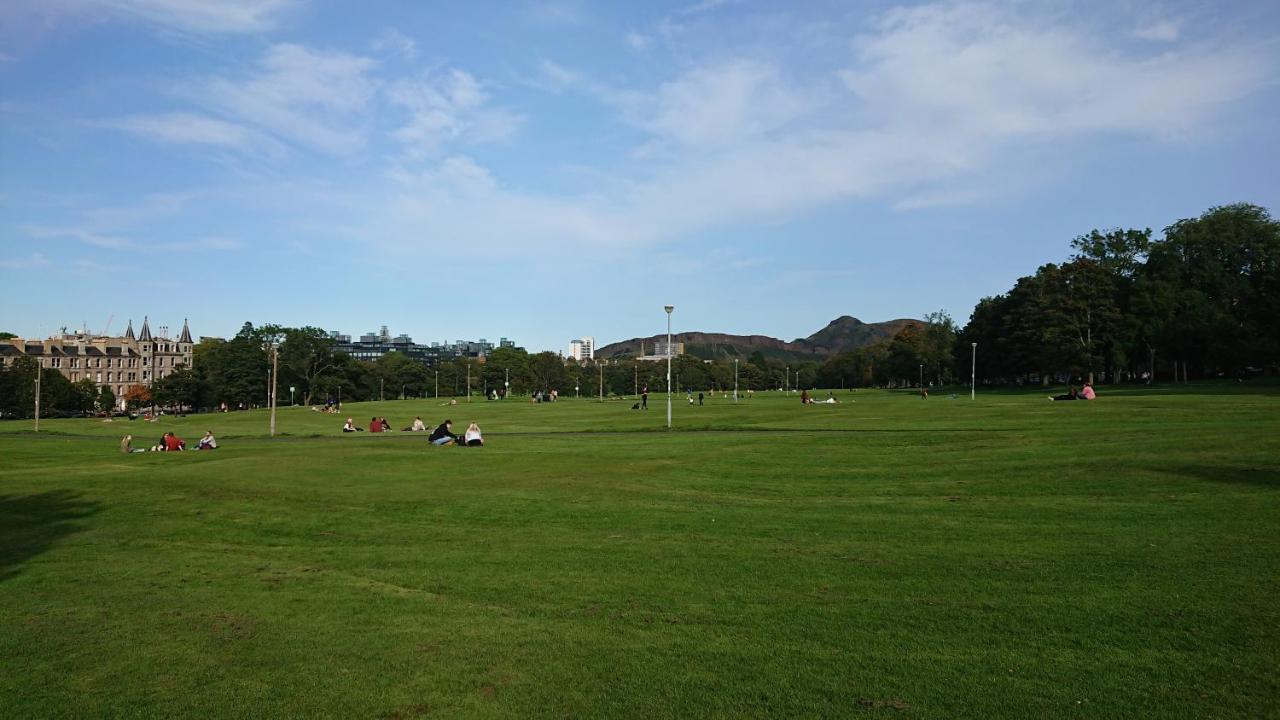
[0,204,1280,416]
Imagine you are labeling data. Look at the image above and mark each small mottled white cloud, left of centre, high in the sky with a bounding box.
[387,69,521,158]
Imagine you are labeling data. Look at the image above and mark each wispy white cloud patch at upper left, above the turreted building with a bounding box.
[187,44,378,155]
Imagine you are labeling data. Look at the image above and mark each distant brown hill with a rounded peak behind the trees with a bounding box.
[595,315,923,361]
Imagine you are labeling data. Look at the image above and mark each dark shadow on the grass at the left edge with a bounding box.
[0,489,102,582]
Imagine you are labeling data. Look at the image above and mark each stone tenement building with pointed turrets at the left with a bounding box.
[0,318,195,407]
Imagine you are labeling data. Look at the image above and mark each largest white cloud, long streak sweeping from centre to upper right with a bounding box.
[353,3,1274,256]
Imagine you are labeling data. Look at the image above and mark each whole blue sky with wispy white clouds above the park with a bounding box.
[0,0,1280,350]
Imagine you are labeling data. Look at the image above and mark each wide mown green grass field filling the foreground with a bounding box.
[0,384,1280,719]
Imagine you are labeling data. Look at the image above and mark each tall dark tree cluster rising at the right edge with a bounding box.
[952,204,1280,383]
